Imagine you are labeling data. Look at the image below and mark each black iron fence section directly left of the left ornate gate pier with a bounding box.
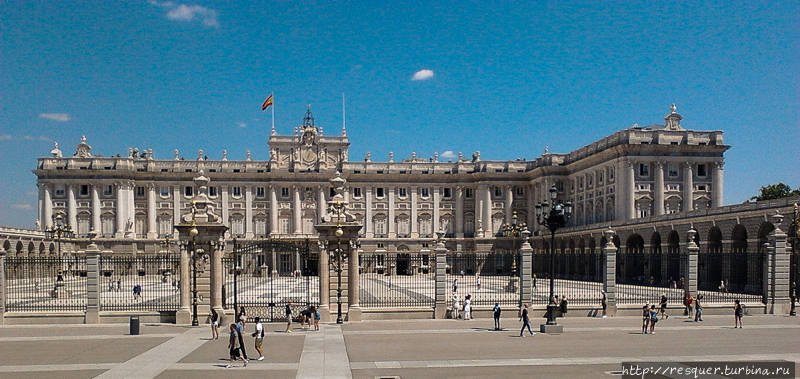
[98,254,180,311]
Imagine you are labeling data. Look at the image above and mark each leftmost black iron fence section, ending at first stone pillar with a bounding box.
[5,257,86,312]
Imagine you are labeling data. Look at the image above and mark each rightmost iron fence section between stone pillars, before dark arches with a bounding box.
[697,252,767,303]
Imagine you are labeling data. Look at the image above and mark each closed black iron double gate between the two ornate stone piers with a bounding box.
[222,240,319,322]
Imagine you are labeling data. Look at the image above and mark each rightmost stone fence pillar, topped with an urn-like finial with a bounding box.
[767,213,792,315]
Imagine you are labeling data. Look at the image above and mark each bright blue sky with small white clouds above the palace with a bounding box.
[0,0,800,227]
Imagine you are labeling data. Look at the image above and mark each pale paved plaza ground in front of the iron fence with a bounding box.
[0,316,800,379]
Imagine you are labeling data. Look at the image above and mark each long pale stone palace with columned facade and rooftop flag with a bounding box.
[33,105,729,252]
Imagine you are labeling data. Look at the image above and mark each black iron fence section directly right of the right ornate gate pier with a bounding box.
[362,253,436,307]
